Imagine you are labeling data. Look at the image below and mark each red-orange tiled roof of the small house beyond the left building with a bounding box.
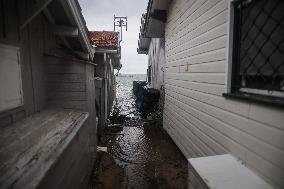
[89,31,119,48]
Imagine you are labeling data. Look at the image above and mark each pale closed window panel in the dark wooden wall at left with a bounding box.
[0,44,23,112]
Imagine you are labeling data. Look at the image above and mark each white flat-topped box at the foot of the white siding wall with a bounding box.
[188,154,272,189]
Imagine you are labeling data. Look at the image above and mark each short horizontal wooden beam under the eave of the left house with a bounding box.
[51,25,79,37]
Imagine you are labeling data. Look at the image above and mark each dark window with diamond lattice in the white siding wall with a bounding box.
[227,0,284,103]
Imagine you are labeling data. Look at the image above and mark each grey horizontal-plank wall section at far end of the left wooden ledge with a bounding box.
[45,55,96,125]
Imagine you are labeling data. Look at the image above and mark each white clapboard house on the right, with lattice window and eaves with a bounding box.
[138,0,284,188]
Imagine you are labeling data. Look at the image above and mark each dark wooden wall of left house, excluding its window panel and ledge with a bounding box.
[0,0,97,188]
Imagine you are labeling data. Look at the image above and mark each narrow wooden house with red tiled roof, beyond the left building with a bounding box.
[89,31,122,139]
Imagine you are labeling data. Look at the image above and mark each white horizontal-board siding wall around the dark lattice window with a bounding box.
[164,0,284,188]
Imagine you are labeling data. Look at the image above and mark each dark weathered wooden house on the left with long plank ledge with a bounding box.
[0,0,96,189]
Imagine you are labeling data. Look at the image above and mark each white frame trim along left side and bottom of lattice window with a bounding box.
[225,0,284,98]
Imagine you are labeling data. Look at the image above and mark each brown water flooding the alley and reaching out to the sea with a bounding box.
[90,75,188,189]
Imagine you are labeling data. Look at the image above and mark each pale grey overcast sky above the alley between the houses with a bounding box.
[79,0,148,74]
